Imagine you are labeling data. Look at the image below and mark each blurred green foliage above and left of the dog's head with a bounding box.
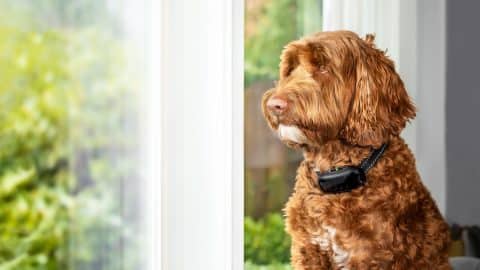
[245,0,322,87]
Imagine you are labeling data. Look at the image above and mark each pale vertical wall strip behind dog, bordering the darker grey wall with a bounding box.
[416,0,447,214]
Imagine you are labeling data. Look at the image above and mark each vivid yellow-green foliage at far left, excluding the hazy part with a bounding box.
[0,28,71,269]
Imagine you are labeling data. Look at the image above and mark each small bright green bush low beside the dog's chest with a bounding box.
[244,214,290,269]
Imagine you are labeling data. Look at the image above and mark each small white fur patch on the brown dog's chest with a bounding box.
[312,226,350,270]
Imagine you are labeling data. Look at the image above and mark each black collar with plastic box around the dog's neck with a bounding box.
[317,143,388,193]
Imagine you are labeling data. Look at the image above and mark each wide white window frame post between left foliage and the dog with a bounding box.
[150,0,244,270]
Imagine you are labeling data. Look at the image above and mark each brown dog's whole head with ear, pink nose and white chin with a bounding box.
[262,31,415,147]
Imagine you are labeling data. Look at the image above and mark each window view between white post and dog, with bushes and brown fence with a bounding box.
[244,0,322,269]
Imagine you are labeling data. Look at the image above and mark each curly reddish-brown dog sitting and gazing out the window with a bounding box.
[262,31,451,270]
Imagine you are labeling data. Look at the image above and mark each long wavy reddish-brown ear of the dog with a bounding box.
[340,38,415,147]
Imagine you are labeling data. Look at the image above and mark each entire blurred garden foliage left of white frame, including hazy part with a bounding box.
[0,4,142,270]
